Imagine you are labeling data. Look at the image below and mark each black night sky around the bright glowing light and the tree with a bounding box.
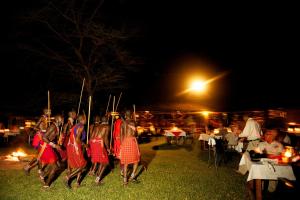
[0,0,300,115]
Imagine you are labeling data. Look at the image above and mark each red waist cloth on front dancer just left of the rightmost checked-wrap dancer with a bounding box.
[90,137,108,163]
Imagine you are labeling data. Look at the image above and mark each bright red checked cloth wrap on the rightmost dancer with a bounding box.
[120,136,140,164]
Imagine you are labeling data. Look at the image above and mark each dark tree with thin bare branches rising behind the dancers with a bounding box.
[20,0,140,103]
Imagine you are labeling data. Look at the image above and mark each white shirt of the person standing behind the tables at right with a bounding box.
[239,118,263,140]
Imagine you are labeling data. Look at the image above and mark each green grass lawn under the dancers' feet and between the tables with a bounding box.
[0,138,247,200]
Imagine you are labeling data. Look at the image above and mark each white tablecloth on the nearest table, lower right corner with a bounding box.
[239,152,296,181]
